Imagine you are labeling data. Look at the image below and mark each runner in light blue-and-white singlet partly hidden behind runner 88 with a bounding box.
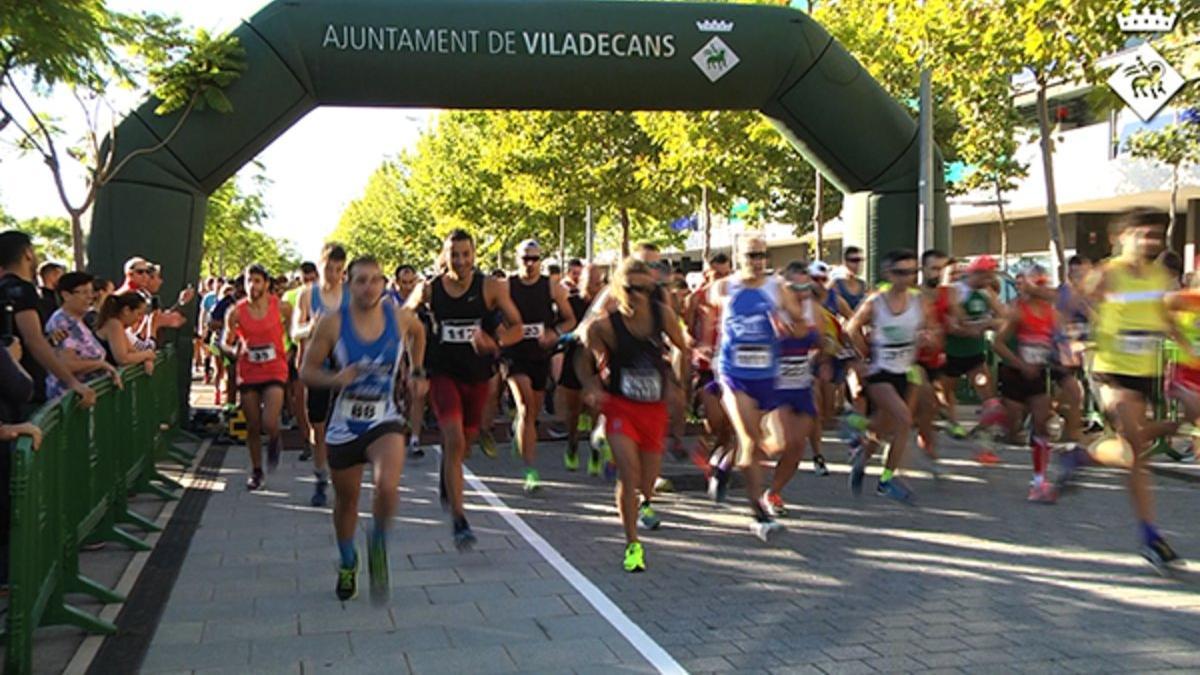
[292,243,349,507]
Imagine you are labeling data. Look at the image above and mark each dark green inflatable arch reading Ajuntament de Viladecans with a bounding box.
[88,0,948,297]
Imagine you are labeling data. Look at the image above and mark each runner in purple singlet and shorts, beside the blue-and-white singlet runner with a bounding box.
[764,261,829,515]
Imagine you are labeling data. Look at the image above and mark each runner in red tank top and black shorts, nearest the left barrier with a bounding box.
[226,264,292,490]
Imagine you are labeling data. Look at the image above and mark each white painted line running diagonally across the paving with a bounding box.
[462,465,688,674]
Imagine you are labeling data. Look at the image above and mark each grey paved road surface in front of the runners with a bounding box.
[136,425,1200,674]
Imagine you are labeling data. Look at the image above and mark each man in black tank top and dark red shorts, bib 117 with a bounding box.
[406,229,521,550]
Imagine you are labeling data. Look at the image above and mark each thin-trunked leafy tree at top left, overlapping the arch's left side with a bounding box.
[0,0,244,269]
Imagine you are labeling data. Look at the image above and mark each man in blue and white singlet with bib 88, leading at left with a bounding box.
[300,257,428,603]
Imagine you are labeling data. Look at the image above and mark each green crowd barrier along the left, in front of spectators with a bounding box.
[4,348,182,675]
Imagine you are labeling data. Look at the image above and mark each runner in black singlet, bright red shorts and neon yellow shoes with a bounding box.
[576,258,689,572]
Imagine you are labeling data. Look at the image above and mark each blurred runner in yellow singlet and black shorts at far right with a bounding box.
[1087,209,1192,573]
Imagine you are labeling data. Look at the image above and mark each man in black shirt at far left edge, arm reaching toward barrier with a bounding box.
[0,229,96,412]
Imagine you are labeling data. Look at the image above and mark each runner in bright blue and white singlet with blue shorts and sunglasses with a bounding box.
[712,237,809,542]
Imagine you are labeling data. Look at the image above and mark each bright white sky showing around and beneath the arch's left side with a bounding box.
[0,0,433,258]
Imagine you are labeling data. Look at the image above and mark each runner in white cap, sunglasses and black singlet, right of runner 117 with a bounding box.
[504,239,575,492]
